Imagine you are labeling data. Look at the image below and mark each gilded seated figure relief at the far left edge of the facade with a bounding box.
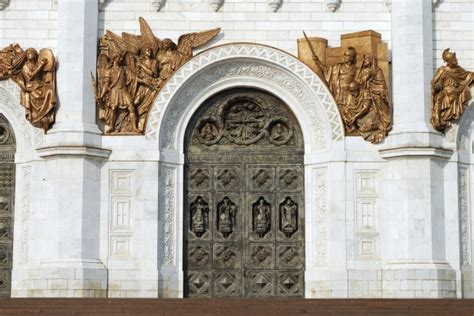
[0,44,56,133]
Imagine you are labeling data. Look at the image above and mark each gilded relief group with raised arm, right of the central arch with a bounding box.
[300,31,392,143]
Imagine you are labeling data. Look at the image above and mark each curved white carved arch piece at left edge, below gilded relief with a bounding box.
[0,80,44,151]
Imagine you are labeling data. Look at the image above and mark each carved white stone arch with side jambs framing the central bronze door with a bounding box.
[152,43,344,297]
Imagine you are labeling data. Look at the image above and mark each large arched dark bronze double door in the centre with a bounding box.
[184,89,304,297]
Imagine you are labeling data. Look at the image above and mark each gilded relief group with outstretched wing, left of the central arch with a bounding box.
[93,18,220,134]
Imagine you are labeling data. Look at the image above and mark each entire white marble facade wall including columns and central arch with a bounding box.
[0,0,474,298]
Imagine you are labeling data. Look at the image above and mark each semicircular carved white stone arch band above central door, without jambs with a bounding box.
[146,43,344,149]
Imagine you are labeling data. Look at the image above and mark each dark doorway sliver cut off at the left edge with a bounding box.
[0,114,16,297]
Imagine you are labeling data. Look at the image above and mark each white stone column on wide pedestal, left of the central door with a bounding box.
[16,0,109,297]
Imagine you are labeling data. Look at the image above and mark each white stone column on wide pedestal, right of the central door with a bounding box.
[380,0,456,298]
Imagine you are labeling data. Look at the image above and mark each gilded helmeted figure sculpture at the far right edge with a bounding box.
[431,48,474,132]
